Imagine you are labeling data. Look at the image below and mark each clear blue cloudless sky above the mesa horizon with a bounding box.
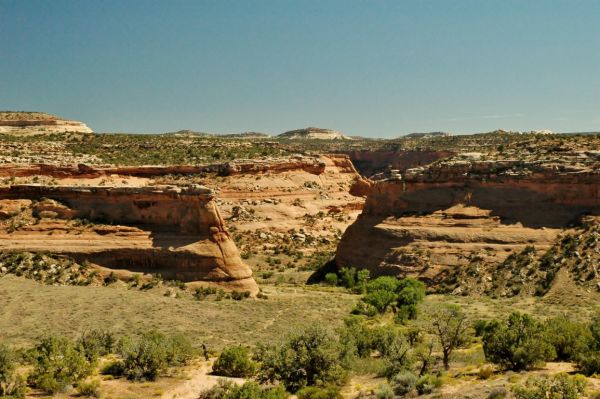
[0,0,600,137]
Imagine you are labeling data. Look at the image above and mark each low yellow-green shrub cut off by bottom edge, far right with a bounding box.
[513,373,586,399]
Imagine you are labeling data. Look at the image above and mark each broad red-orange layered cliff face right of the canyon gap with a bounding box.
[336,162,600,281]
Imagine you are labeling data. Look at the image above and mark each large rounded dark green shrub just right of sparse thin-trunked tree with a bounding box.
[483,312,555,370]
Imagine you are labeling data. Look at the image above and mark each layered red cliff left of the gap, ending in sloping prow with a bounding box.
[0,185,258,293]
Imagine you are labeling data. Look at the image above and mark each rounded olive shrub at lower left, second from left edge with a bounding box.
[28,336,94,393]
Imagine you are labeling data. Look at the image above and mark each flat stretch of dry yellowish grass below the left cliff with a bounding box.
[0,276,357,349]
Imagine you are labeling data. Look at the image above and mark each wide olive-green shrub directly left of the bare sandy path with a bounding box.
[119,331,193,381]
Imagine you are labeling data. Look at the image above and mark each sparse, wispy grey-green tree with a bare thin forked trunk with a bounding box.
[429,304,469,370]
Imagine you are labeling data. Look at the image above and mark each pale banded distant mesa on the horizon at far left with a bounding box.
[0,111,93,135]
